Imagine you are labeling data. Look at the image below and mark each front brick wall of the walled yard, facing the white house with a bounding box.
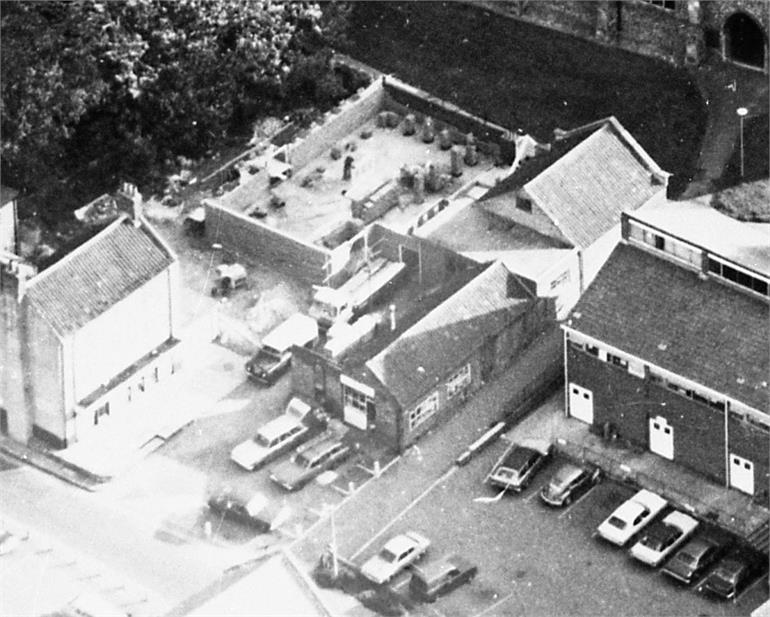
[204,201,329,284]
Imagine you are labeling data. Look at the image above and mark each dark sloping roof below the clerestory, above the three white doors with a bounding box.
[568,244,770,413]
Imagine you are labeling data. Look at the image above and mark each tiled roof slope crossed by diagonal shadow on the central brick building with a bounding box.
[366,263,530,407]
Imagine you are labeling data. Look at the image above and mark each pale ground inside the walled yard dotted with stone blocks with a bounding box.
[212,118,494,243]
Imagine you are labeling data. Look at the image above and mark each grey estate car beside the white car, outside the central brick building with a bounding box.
[270,424,352,491]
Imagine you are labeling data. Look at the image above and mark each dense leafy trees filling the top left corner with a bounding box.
[0,0,347,221]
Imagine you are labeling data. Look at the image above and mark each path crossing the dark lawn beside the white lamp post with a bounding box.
[683,59,768,198]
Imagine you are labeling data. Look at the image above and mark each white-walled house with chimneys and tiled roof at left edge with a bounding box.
[0,185,178,447]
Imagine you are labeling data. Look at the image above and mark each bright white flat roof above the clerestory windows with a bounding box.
[629,195,770,276]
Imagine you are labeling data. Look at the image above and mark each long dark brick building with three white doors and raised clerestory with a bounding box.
[563,203,770,505]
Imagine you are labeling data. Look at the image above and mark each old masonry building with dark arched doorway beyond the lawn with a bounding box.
[474,0,770,71]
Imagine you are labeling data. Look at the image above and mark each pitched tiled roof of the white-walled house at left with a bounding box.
[25,215,175,334]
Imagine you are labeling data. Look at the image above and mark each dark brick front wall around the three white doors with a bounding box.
[567,347,770,498]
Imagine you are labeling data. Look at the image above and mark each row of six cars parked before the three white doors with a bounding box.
[486,440,757,599]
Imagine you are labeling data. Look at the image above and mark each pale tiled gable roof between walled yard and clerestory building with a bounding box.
[485,117,668,248]
